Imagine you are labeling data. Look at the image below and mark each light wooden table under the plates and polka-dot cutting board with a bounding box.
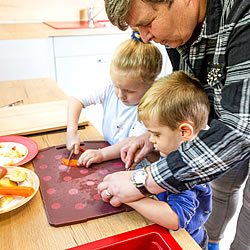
[0,78,200,250]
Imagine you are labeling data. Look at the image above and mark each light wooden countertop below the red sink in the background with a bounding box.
[0,23,130,40]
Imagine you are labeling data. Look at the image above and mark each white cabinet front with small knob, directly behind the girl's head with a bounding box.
[54,33,129,95]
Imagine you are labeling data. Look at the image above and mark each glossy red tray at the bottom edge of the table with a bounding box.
[68,224,182,250]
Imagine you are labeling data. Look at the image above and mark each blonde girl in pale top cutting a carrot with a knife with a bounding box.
[67,30,162,167]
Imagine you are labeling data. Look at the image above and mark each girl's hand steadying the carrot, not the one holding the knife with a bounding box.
[78,149,103,168]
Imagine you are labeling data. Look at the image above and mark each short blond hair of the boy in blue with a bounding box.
[138,71,210,132]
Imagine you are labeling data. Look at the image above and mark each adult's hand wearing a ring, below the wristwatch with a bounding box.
[98,171,144,207]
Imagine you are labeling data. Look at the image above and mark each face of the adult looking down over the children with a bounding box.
[127,0,198,48]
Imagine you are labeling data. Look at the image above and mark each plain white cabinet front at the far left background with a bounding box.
[0,38,55,81]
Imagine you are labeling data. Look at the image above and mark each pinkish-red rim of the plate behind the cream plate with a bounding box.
[0,135,38,166]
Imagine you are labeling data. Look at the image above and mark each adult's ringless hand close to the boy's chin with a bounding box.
[121,132,154,169]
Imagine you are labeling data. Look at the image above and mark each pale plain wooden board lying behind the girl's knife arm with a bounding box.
[0,100,88,136]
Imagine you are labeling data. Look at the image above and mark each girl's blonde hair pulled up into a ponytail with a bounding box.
[110,33,162,84]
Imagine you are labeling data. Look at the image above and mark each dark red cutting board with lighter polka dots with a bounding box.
[33,141,132,226]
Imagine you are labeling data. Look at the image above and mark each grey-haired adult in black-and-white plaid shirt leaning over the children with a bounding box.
[99,0,250,250]
